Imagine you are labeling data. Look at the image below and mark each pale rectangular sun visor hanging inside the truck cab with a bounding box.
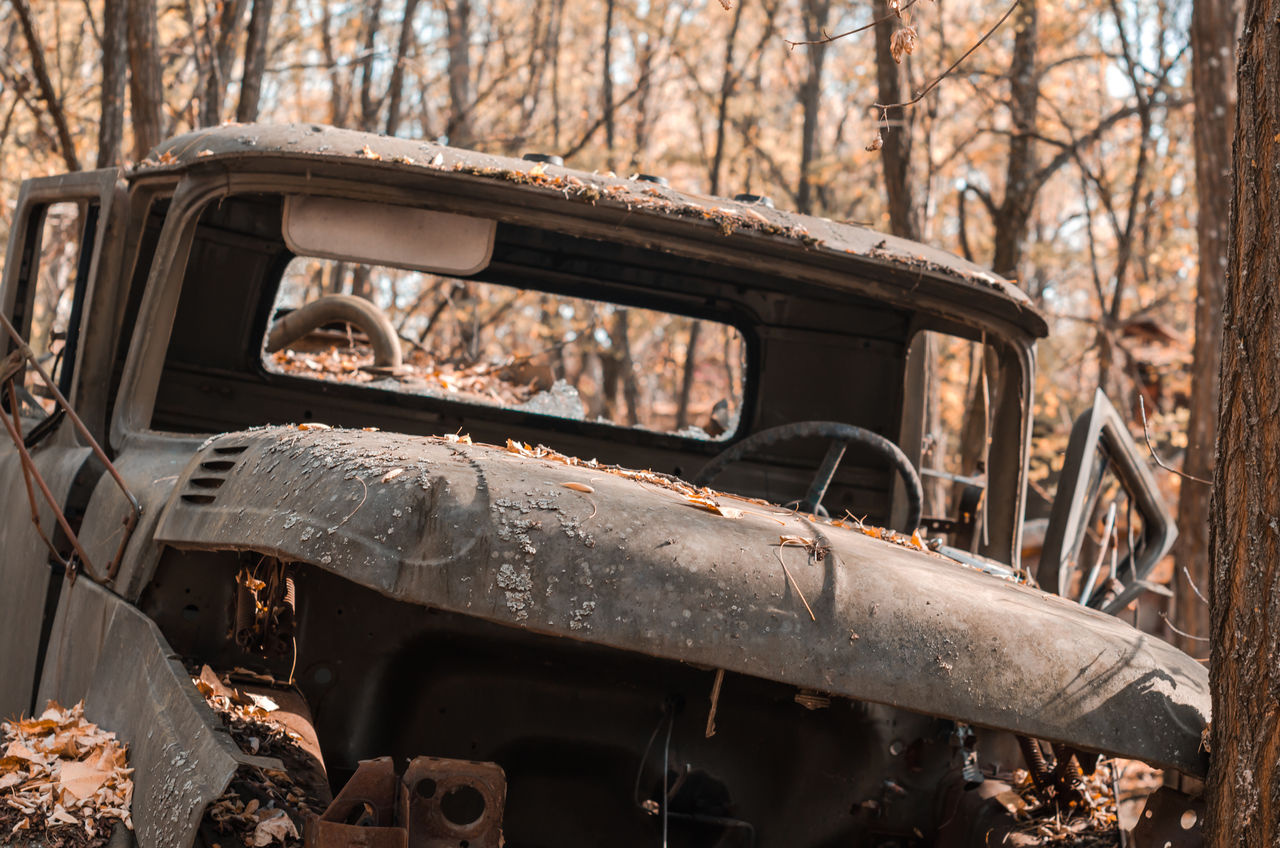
[284,195,498,275]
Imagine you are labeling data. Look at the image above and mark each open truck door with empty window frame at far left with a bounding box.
[0,169,123,717]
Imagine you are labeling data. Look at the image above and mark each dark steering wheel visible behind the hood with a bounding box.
[692,421,924,533]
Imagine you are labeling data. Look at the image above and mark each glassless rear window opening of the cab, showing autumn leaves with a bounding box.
[262,256,745,439]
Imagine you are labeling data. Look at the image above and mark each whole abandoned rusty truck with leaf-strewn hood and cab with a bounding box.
[0,126,1208,848]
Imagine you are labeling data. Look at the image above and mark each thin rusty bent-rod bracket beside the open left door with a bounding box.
[0,313,142,585]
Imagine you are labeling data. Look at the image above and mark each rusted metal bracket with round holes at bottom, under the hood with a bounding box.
[305,757,507,848]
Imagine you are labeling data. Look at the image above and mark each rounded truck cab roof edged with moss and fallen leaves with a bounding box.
[137,123,1048,338]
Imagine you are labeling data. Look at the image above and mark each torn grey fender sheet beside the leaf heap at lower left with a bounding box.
[41,580,254,848]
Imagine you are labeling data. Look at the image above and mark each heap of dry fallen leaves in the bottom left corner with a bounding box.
[0,701,133,848]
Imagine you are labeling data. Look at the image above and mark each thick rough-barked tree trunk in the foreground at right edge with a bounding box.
[1207,0,1280,848]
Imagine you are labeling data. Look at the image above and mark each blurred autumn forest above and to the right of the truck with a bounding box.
[0,0,1236,656]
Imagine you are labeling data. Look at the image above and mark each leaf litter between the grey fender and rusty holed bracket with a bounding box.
[192,666,330,848]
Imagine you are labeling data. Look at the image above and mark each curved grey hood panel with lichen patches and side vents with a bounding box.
[155,427,1210,774]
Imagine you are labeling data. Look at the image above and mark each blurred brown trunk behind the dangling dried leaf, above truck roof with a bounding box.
[872,0,920,241]
